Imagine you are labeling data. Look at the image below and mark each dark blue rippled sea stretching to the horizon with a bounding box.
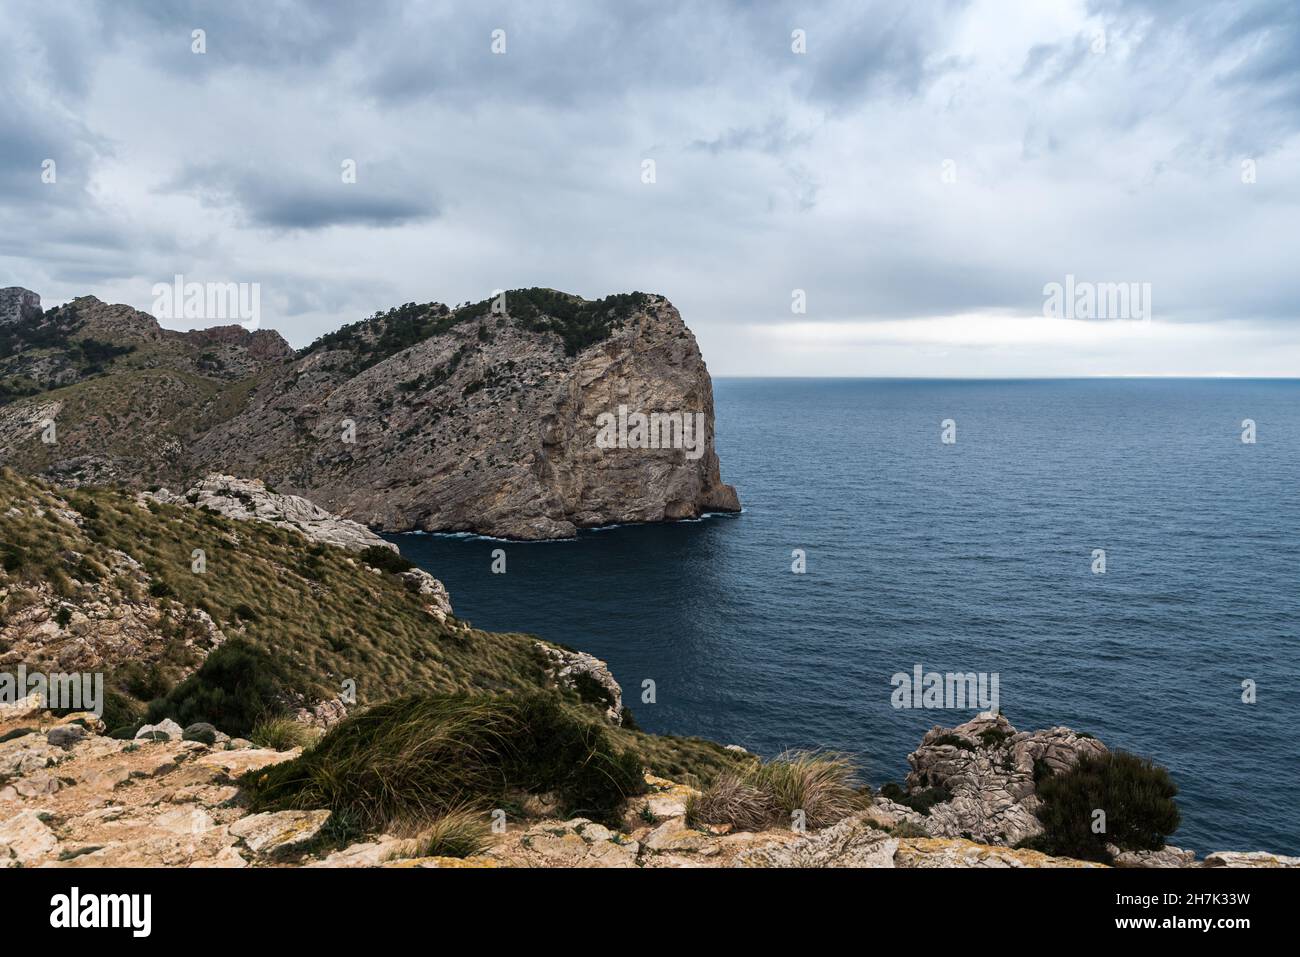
[394,380,1300,854]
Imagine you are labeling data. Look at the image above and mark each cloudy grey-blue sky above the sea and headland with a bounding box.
[0,0,1300,377]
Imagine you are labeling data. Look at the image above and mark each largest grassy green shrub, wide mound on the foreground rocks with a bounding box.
[243,693,645,827]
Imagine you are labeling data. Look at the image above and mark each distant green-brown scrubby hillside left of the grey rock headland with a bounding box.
[0,289,293,482]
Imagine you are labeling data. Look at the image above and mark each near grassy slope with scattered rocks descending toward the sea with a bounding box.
[0,469,725,772]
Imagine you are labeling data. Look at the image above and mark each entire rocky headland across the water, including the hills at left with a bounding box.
[0,289,740,538]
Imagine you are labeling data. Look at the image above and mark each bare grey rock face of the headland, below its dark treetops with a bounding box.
[195,287,740,538]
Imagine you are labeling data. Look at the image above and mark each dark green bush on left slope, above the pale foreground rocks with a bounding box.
[147,638,301,737]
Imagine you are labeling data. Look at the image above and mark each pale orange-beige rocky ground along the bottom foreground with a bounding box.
[0,698,1300,867]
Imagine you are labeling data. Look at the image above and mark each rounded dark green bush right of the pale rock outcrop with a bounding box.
[1027,752,1180,863]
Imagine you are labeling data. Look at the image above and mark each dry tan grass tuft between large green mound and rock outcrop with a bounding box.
[686,752,863,831]
